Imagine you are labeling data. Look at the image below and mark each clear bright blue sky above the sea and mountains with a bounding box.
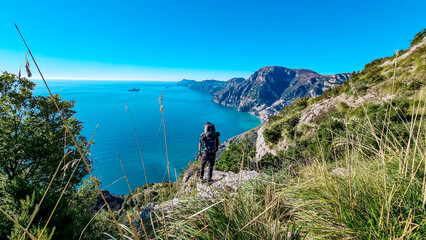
[0,0,426,81]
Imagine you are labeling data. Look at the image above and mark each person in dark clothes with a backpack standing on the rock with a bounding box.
[198,122,220,182]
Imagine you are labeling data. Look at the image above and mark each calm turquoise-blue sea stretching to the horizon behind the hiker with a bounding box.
[34,80,261,194]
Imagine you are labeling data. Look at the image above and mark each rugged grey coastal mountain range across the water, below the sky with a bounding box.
[179,66,350,120]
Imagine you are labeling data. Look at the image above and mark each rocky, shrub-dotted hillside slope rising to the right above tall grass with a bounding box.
[258,31,426,160]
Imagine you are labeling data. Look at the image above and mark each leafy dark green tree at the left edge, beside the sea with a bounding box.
[0,72,97,239]
